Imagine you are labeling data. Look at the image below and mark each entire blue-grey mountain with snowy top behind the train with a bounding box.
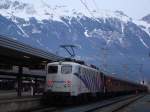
[0,0,150,80]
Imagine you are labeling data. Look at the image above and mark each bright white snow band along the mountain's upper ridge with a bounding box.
[0,0,130,21]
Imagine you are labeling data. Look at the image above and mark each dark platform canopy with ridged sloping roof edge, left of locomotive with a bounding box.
[0,35,63,66]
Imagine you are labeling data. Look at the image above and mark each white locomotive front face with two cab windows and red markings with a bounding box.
[45,62,78,97]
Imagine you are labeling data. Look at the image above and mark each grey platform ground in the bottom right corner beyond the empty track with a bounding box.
[121,94,150,112]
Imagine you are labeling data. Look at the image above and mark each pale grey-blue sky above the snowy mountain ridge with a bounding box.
[22,0,150,19]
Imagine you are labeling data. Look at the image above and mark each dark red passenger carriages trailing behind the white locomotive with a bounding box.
[104,75,147,95]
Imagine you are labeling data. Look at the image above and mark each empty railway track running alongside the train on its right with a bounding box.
[61,95,144,112]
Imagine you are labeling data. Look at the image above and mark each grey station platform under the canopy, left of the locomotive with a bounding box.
[0,95,41,112]
